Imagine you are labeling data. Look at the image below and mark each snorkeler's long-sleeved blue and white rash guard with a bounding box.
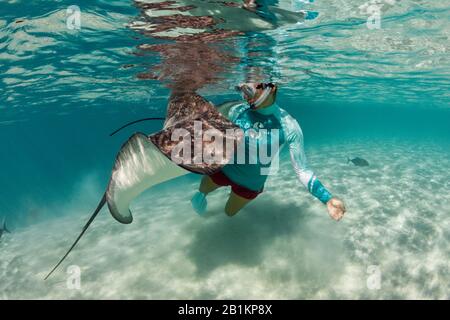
[219,103,332,203]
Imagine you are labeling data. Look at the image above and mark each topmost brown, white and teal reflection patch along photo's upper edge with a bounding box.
[129,0,306,41]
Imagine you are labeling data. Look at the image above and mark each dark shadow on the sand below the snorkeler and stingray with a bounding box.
[188,199,308,277]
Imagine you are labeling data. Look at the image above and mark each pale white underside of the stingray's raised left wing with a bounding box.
[106,133,189,223]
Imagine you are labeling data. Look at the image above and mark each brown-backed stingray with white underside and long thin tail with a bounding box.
[45,93,243,280]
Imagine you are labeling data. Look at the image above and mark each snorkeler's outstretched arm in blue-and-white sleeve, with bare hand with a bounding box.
[282,115,345,220]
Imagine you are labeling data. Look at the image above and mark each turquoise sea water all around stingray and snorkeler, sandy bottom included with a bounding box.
[0,0,450,299]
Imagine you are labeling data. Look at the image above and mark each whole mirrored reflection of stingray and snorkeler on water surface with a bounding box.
[130,0,294,94]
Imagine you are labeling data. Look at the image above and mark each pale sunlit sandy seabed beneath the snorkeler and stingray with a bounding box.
[0,141,450,299]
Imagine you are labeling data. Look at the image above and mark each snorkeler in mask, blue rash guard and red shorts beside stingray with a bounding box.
[191,83,346,220]
